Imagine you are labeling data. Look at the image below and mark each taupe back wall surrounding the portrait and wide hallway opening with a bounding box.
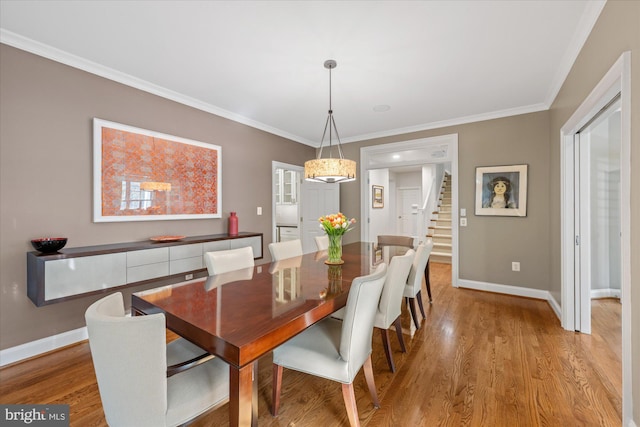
[340,111,549,289]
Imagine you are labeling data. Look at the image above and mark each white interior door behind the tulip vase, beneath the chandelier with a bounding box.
[300,180,340,253]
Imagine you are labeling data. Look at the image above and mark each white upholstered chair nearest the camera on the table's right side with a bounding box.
[271,263,387,426]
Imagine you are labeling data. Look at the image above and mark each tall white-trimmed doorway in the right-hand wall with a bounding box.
[561,52,631,424]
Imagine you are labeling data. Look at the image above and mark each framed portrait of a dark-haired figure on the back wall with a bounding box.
[476,165,528,217]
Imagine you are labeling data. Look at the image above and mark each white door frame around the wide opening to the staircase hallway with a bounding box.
[360,133,460,288]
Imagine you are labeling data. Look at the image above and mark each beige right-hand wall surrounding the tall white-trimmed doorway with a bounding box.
[549,0,640,425]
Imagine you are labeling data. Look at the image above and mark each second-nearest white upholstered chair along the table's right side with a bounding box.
[331,249,415,372]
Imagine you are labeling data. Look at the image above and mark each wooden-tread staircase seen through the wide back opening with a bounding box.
[427,173,451,264]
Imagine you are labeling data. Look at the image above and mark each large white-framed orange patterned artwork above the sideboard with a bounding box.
[93,118,222,222]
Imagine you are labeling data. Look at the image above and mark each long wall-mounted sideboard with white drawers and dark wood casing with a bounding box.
[27,232,262,306]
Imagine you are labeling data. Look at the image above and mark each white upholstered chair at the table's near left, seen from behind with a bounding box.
[85,292,229,427]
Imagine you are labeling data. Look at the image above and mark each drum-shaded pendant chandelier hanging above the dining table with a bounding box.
[304,59,356,184]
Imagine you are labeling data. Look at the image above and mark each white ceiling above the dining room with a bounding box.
[0,0,604,146]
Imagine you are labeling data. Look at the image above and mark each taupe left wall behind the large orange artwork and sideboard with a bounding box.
[0,45,315,349]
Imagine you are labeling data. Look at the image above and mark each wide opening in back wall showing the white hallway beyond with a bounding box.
[360,134,458,287]
